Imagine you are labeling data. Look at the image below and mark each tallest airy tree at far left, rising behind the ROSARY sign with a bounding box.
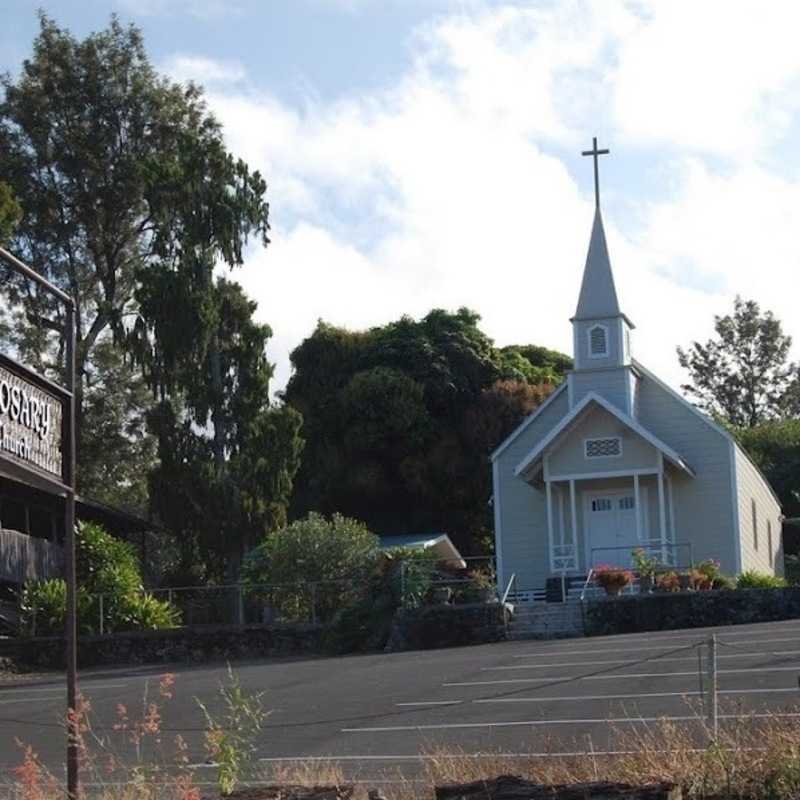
[0,14,269,494]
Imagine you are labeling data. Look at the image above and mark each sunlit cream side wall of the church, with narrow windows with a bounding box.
[733,444,783,575]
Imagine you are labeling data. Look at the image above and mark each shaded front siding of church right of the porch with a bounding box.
[637,375,739,574]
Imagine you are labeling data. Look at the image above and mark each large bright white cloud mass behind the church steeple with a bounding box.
[175,2,800,396]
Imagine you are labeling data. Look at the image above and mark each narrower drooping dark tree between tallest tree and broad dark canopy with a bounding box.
[140,282,303,581]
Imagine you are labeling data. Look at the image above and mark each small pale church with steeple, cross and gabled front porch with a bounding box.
[491,145,783,591]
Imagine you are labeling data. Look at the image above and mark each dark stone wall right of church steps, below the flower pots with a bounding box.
[584,586,800,636]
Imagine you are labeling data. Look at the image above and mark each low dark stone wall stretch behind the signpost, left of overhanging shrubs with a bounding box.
[0,625,324,669]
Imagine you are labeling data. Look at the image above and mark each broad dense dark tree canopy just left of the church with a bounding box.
[285,309,571,552]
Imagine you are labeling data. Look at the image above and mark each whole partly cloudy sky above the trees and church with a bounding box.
[0,0,800,389]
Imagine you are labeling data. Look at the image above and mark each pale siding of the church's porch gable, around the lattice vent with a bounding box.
[550,405,658,475]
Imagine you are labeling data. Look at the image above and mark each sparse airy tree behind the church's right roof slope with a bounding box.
[678,297,798,427]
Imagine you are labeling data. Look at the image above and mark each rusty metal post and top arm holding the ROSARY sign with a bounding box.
[0,247,79,800]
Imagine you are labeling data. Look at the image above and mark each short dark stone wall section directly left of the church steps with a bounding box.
[386,602,506,653]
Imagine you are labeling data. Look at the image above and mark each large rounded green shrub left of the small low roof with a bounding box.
[242,512,380,621]
